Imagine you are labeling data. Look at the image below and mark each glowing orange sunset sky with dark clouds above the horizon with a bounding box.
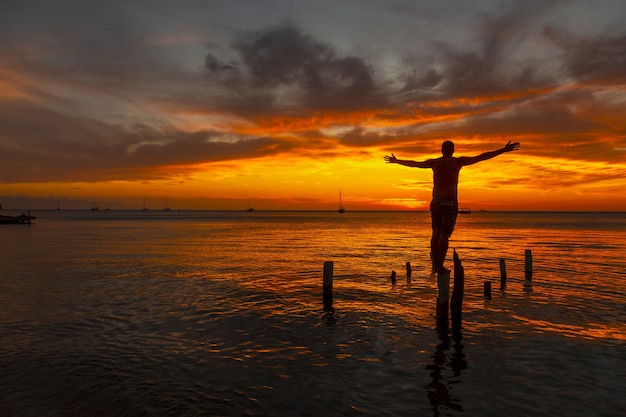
[0,0,626,211]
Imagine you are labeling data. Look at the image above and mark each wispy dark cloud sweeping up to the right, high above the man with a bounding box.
[392,2,555,100]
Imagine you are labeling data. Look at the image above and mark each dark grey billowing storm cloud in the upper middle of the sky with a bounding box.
[205,25,385,111]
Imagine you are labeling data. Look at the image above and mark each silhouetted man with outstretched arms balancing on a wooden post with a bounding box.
[385,140,520,273]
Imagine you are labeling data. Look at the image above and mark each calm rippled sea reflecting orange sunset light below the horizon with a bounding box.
[0,210,626,417]
